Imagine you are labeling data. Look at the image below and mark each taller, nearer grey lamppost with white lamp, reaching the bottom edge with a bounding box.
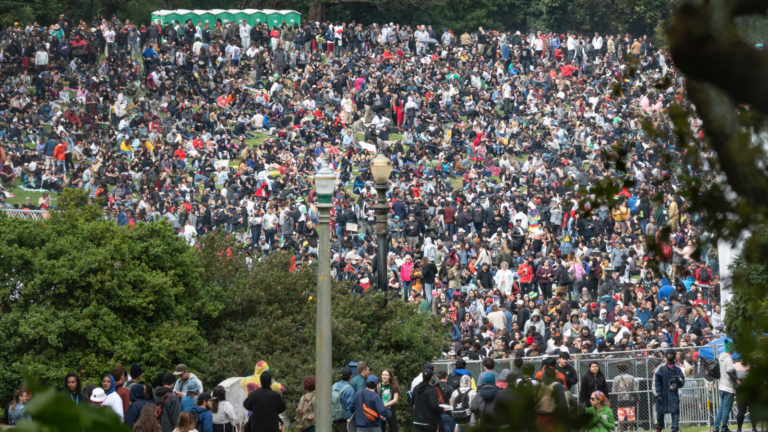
[315,166,336,432]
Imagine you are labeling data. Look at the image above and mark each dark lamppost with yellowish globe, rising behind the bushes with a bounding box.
[371,153,392,297]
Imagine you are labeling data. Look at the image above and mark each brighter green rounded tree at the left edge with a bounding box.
[0,191,221,402]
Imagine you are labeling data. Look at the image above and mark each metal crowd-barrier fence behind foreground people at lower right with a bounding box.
[434,347,749,430]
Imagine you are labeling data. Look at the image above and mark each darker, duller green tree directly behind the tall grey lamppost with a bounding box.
[198,236,448,428]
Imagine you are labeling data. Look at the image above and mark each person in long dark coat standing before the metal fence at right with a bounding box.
[653,349,685,432]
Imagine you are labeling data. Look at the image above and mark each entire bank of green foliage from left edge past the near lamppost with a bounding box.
[0,190,447,428]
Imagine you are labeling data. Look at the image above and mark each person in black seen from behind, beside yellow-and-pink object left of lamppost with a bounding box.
[243,371,285,432]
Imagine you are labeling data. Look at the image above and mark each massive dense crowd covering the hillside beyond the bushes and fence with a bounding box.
[0,10,736,432]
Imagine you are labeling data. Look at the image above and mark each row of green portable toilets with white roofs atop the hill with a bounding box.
[152,9,301,27]
